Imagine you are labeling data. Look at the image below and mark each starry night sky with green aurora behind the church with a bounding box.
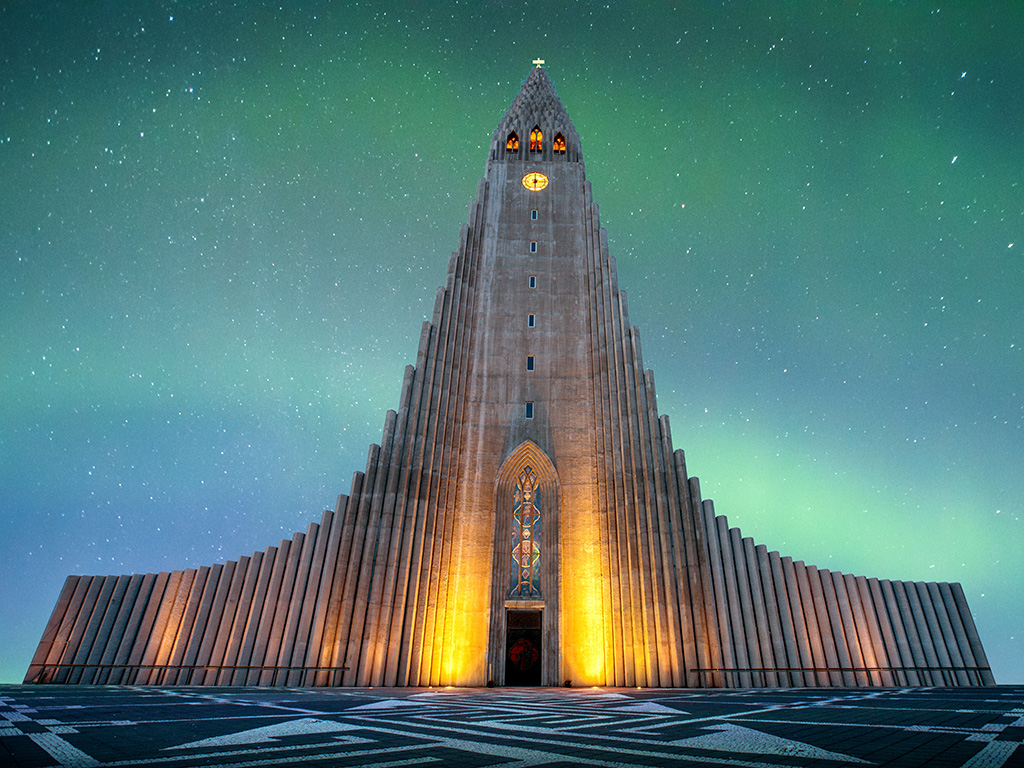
[0,2,1024,683]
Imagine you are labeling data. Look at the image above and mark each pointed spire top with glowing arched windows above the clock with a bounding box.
[490,67,582,163]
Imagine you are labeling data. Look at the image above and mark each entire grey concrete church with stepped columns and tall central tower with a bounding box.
[25,61,994,688]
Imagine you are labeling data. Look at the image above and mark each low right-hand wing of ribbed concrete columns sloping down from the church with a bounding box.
[702,501,995,687]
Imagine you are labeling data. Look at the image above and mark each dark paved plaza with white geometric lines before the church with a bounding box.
[0,685,1024,768]
